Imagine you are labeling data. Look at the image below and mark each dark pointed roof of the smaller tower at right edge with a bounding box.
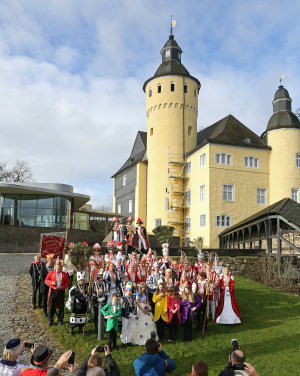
[262,85,300,136]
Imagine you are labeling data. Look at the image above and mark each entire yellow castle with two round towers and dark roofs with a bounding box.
[112,34,300,248]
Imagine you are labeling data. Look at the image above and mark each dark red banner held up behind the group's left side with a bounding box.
[40,232,67,259]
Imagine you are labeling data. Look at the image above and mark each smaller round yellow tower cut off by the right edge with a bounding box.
[262,85,300,205]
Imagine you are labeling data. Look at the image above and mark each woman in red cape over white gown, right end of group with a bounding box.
[216,268,241,324]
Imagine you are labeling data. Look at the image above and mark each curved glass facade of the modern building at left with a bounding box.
[0,194,71,228]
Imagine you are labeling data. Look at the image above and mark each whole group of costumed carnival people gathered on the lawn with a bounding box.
[30,217,241,349]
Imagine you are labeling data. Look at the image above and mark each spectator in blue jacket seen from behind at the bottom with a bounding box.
[133,338,176,376]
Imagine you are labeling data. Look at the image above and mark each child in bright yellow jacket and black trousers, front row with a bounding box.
[152,280,168,339]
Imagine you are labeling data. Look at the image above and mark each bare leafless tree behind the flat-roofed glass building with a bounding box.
[0,160,33,183]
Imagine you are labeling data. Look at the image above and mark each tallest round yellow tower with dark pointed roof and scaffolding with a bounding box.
[143,34,201,235]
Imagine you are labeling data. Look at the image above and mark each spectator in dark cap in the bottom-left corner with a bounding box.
[0,338,30,376]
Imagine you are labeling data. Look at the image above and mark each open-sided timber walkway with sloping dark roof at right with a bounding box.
[219,198,300,255]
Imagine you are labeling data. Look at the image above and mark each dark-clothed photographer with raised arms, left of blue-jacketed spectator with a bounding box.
[77,346,120,376]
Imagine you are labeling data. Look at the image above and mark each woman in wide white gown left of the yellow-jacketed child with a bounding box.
[131,282,156,346]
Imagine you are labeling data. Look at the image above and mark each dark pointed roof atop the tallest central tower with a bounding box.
[143,34,201,91]
